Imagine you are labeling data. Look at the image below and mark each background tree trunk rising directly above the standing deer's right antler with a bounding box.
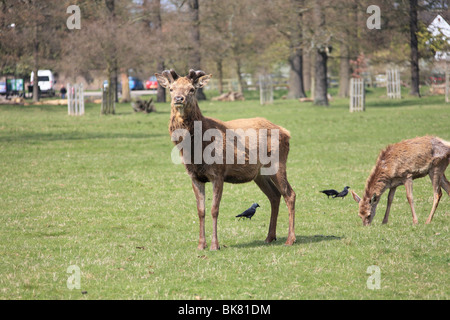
[188,0,206,100]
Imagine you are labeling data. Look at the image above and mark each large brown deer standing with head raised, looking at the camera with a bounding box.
[155,69,295,250]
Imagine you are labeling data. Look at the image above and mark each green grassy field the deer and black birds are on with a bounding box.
[0,89,450,299]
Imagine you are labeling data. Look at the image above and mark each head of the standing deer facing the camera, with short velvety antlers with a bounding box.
[155,69,212,116]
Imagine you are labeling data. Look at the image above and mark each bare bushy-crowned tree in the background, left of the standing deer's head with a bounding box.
[64,0,146,112]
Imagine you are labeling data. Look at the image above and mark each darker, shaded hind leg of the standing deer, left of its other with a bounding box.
[255,175,281,243]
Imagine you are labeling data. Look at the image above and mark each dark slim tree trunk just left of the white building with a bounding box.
[409,0,420,97]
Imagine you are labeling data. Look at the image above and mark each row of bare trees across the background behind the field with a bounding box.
[0,0,448,105]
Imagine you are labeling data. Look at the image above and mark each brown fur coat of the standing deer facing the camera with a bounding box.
[156,70,295,250]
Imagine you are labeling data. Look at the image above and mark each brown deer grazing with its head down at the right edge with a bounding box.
[352,136,450,225]
